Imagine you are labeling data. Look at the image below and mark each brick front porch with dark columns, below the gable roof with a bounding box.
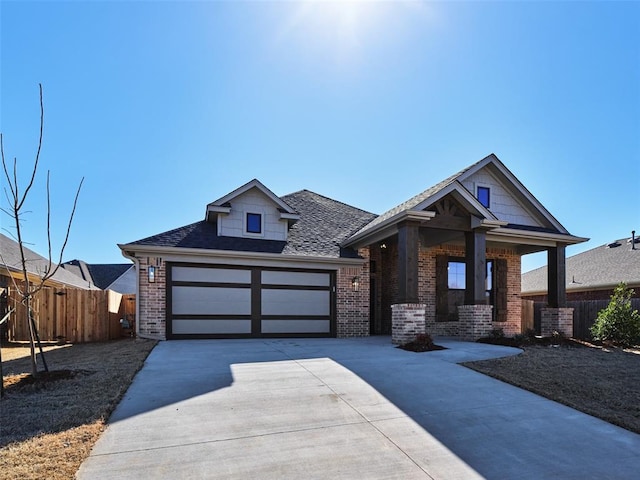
[369,222,572,344]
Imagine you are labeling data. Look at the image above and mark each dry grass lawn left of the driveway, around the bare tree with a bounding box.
[0,338,156,480]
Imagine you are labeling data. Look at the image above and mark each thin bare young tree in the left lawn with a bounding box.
[0,84,84,377]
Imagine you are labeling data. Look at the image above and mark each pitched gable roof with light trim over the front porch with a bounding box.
[345,154,586,246]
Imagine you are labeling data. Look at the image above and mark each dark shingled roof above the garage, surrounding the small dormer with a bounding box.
[121,189,375,258]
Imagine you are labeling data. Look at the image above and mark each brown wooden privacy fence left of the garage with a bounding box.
[8,287,136,343]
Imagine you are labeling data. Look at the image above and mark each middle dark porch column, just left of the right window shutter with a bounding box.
[464,229,487,305]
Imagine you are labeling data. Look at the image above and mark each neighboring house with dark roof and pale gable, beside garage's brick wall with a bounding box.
[60,260,137,295]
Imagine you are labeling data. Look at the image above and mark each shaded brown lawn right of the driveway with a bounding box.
[463,344,640,433]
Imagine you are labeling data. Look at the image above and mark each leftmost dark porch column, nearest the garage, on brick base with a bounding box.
[398,222,418,303]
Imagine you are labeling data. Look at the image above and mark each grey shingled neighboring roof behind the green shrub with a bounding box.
[522,237,640,295]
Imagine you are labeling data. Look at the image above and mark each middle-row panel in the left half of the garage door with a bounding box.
[172,286,251,315]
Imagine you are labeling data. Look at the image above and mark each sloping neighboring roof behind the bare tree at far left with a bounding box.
[0,234,93,290]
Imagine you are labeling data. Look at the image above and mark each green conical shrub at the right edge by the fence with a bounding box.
[591,282,640,347]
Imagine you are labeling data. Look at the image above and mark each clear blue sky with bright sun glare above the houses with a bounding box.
[0,0,640,271]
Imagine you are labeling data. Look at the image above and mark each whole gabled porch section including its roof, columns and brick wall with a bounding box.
[345,155,586,343]
